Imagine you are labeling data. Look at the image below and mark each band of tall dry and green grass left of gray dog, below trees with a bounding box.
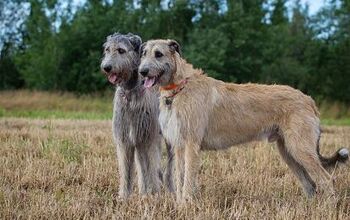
[0,90,113,119]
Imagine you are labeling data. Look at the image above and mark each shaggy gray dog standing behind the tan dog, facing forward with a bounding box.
[101,33,174,198]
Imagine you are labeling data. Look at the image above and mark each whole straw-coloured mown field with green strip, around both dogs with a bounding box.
[0,91,350,219]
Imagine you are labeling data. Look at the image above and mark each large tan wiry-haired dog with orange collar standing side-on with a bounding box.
[139,40,348,200]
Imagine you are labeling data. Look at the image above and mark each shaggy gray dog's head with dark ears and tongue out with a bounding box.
[101,33,142,84]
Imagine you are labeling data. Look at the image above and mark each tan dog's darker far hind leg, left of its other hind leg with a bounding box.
[277,138,316,197]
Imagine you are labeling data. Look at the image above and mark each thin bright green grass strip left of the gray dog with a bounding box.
[0,108,112,120]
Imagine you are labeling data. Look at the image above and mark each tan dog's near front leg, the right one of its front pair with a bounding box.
[182,143,200,201]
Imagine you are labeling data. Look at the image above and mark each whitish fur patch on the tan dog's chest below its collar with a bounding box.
[159,109,183,147]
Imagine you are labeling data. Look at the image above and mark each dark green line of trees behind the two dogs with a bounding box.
[0,0,350,103]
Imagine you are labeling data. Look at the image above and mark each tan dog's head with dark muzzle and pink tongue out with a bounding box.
[139,40,180,88]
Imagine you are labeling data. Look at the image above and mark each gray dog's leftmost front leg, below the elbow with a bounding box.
[117,145,135,198]
